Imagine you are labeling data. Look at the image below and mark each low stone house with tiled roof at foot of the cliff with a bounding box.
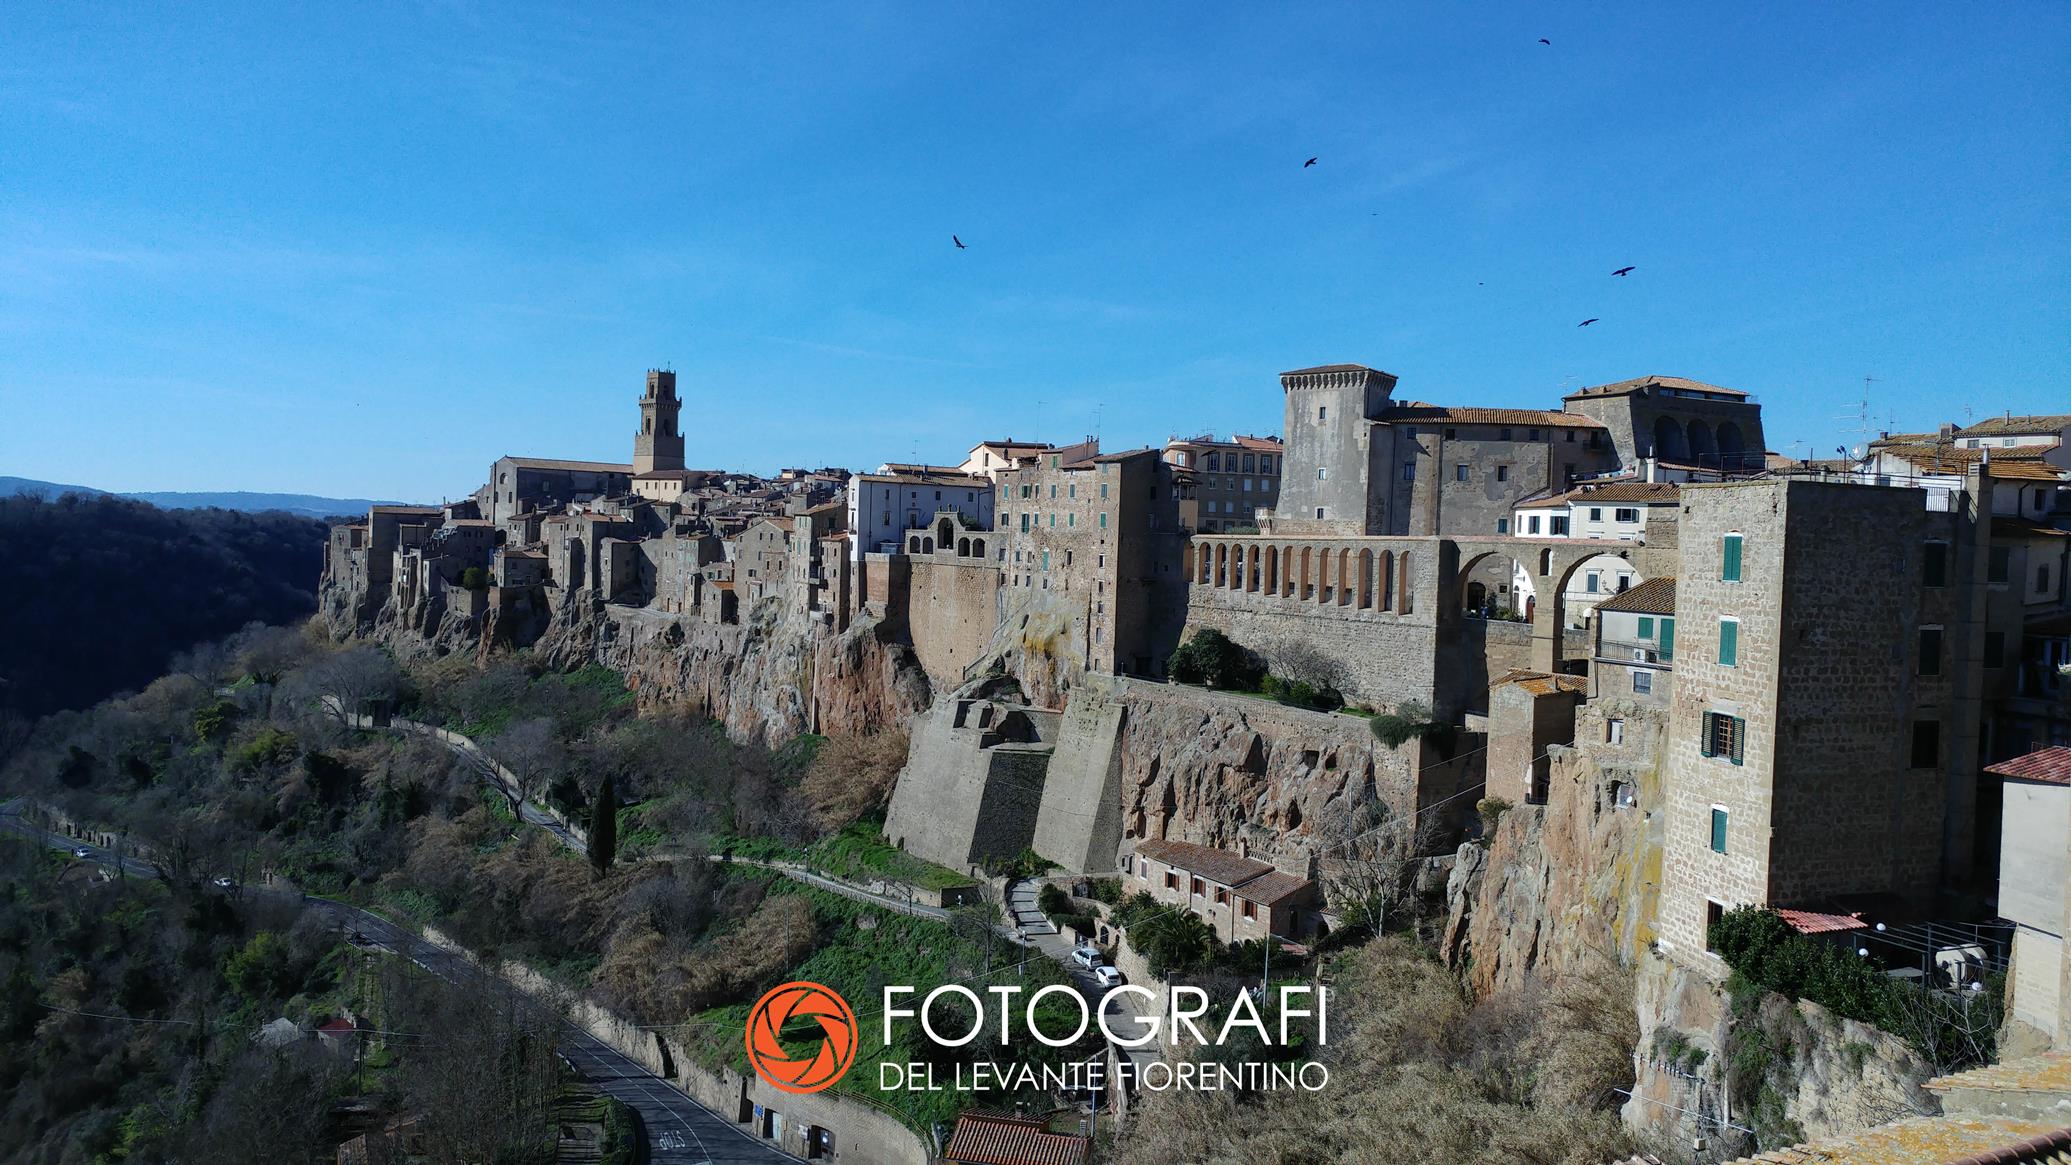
[1122,840,1321,942]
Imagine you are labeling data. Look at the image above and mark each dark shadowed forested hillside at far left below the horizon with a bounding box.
[0,495,327,718]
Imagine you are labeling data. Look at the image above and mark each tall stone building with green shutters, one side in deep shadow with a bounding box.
[1661,478,1978,960]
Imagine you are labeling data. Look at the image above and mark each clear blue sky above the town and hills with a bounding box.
[0,2,2071,499]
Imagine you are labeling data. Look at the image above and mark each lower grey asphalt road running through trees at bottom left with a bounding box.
[0,799,797,1165]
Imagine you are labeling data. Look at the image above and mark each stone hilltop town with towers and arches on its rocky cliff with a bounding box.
[321,364,2071,1165]
